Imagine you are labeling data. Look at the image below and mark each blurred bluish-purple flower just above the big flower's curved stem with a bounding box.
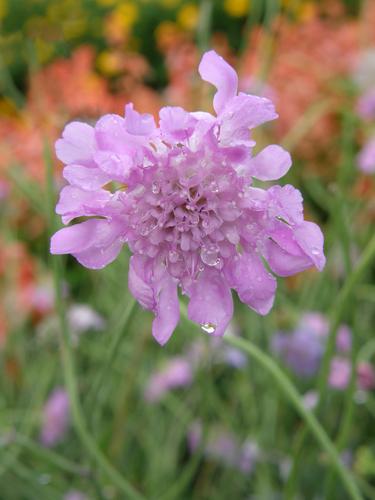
[271,329,323,377]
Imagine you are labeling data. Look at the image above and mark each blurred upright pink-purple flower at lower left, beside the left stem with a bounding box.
[40,388,70,446]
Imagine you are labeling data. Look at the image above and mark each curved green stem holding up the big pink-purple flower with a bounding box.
[223,335,362,500]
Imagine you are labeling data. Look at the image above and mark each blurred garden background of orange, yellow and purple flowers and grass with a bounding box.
[0,0,375,500]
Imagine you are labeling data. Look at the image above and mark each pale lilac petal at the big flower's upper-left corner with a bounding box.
[55,122,96,166]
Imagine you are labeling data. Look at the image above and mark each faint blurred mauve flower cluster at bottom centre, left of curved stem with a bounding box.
[188,422,259,474]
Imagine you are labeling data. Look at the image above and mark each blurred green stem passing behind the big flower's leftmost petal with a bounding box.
[45,146,143,500]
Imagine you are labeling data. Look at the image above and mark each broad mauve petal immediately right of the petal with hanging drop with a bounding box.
[227,252,277,315]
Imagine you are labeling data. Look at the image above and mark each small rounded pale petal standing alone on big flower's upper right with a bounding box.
[248,144,292,181]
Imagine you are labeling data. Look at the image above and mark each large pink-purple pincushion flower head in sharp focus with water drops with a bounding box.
[51,51,325,344]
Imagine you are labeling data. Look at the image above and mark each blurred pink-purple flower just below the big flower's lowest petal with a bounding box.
[144,357,193,403]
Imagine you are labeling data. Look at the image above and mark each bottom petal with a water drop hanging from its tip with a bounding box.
[188,269,233,336]
